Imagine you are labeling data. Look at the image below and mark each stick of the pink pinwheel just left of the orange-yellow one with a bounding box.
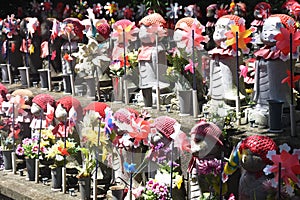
[192,30,198,118]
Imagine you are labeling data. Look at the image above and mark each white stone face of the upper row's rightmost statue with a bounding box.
[260,17,284,46]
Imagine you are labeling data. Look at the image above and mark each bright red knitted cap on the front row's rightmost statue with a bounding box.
[239,135,277,164]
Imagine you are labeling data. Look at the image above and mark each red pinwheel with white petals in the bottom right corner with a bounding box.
[264,145,300,191]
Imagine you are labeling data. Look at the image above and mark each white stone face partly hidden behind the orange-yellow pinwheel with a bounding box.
[213,18,231,46]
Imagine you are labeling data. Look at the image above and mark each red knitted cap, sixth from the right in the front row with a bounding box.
[56,96,83,121]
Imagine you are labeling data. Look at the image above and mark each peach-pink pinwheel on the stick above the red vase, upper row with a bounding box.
[111,20,138,46]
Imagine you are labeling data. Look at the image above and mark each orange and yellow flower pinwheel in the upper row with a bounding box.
[225,23,252,53]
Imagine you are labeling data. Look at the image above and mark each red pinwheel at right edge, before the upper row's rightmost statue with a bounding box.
[274,26,300,56]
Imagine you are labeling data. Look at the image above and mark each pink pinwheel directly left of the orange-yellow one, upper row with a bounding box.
[180,19,209,53]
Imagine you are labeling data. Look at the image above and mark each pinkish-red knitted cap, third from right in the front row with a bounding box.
[153,116,176,138]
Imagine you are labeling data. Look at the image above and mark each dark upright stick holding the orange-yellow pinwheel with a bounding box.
[235,32,241,125]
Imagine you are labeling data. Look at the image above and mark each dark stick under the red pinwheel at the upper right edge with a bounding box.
[290,33,296,137]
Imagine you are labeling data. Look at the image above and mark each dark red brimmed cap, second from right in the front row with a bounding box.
[190,120,223,145]
